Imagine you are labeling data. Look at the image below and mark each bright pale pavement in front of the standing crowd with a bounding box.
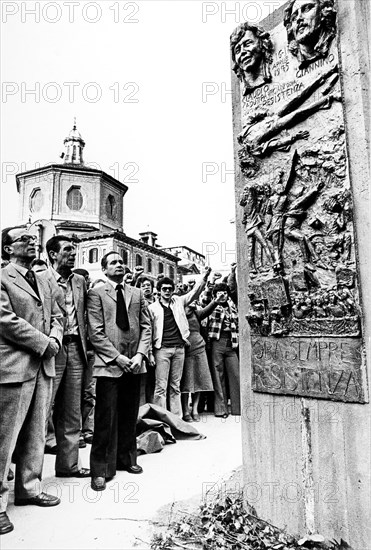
[0,414,242,550]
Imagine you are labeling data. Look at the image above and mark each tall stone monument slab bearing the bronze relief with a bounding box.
[231,0,371,548]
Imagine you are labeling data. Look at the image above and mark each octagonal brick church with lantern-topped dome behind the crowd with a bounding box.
[16,123,182,281]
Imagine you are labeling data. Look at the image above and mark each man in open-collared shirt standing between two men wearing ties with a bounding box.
[43,235,90,477]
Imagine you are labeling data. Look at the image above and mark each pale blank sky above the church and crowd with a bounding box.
[1,0,283,269]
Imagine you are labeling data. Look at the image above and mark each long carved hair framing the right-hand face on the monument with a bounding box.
[283,0,336,61]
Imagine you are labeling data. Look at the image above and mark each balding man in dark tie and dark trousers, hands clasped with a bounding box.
[87,251,151,491]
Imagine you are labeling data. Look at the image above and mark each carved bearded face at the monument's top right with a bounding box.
[291,0,320,44]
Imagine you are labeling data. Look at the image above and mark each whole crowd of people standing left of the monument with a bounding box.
[0,226,240,534]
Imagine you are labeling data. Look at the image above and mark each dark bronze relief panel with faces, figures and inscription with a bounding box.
[231,0,366,402]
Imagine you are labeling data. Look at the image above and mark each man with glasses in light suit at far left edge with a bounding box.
[0,227,63,534]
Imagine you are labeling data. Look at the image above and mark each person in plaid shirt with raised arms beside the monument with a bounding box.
[208,283,241,418]
